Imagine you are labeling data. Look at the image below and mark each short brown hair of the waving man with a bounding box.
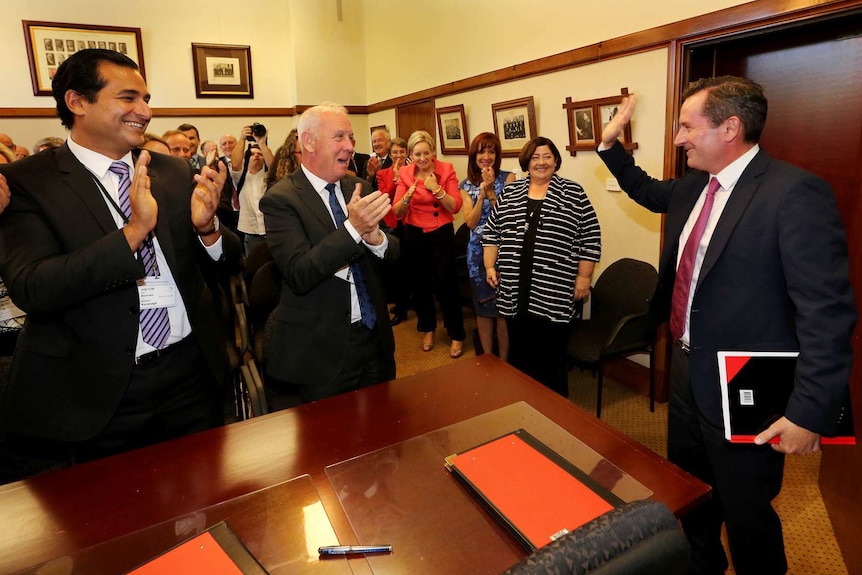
[682,76,768,143]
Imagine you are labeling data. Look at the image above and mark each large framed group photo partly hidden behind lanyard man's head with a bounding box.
[21,20,147,96]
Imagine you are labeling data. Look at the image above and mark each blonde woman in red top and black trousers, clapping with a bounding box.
[392,130,466,358]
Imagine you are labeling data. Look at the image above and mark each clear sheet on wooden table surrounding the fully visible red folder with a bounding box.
[326,401,652,575]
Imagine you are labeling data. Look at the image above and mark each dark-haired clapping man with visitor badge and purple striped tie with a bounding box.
[0,49,240,468]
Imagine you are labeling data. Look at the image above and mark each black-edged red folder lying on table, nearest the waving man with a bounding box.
[446,429,623,551]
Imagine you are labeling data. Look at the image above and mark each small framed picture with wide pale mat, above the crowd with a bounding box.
[192,44,254,98]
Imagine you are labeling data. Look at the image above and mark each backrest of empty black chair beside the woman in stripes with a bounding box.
[590,258,658,325]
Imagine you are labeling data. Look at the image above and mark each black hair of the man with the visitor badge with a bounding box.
[51,48,138,129]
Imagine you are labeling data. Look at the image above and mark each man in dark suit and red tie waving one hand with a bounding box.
[599,76,856,575]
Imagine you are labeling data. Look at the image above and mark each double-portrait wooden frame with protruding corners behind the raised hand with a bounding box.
[563,88,638,156]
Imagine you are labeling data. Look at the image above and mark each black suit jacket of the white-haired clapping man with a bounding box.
[260,169,399,385]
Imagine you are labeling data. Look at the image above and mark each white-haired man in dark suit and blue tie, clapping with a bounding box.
[260,104,399,401]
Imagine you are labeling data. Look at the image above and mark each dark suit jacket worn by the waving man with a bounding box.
[599,143,856,434]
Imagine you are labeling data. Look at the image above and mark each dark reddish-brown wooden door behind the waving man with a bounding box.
[683,13,862,575]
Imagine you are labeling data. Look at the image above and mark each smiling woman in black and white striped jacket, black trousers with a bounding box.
[482,137,602,396]
